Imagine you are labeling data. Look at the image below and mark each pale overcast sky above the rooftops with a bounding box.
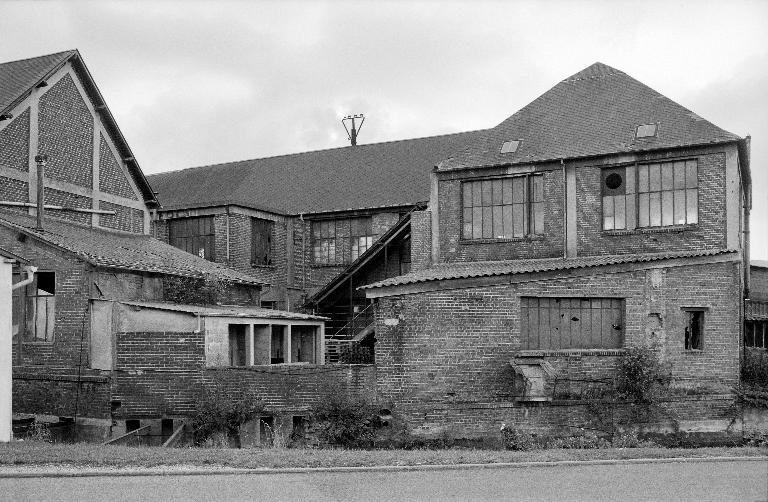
[0,0,768,259]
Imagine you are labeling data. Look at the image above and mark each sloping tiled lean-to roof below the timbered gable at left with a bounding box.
[0,210,264,285]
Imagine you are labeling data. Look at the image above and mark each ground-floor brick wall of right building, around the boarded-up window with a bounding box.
[376,263,739,434]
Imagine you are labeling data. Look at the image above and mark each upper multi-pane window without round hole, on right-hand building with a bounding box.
[462,175,544,239]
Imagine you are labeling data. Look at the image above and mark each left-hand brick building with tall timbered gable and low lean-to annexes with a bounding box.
[0,51,372,441]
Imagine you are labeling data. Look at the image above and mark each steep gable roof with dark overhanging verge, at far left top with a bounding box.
[0,49,157,206]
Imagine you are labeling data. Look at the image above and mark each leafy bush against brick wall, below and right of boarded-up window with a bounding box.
[616,347,672,404]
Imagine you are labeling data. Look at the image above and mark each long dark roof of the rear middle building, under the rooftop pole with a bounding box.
[149,131,483,214]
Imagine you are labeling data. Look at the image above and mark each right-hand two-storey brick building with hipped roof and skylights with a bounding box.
[365,63,750,435]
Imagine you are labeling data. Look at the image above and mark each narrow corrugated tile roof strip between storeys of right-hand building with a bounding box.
[358,249,734,289]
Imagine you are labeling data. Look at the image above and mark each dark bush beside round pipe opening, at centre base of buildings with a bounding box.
[312,391,381,448]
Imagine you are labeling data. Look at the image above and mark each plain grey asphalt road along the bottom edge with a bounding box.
[0,461,768,502]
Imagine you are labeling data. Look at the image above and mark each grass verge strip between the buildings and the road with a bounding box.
[0,441,768,470]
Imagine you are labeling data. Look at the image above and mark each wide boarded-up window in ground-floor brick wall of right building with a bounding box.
[520,297,624,350]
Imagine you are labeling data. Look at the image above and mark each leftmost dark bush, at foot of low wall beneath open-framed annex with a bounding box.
[191,387,264,446]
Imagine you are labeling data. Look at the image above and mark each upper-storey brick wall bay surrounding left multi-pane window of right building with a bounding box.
[438,170,563,262]
